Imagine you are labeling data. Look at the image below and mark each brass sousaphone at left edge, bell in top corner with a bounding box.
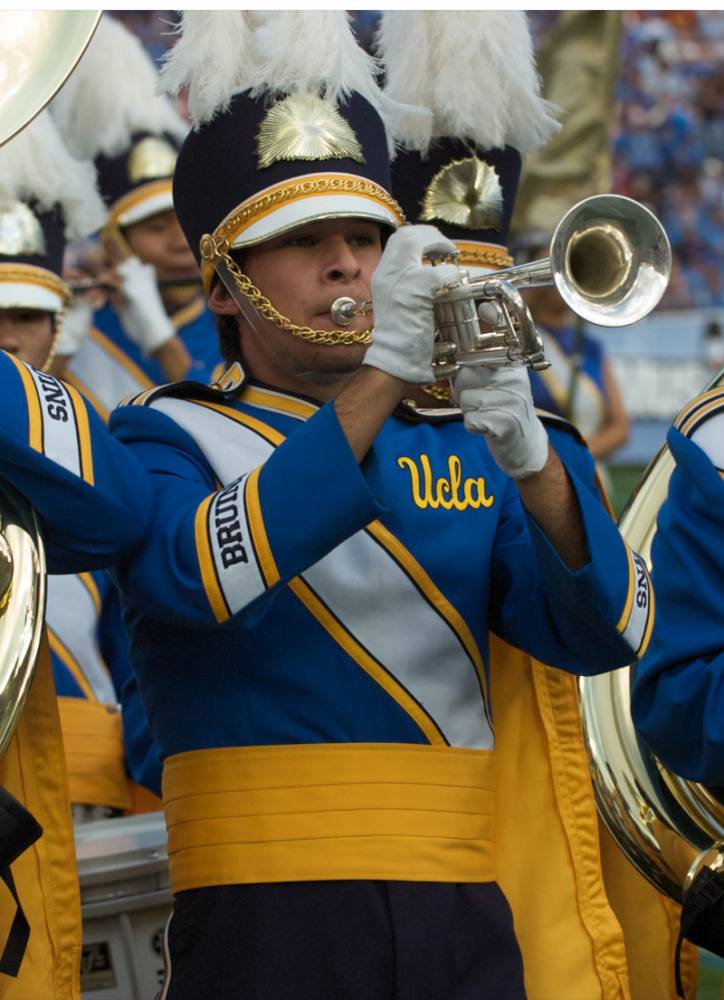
[0,10,100,756]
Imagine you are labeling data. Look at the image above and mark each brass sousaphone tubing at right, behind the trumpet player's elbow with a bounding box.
[579,370,724,903]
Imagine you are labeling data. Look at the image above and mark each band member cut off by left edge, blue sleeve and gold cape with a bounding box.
[0,114,150,1000]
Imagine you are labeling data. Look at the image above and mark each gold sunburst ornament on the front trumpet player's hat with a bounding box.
[257,94,365,169]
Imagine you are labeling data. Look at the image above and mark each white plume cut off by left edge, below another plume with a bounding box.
[0,112,107,240]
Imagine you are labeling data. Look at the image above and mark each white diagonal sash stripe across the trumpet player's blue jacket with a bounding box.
[152,399,493,749]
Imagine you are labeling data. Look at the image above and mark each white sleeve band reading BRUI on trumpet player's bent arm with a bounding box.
[208,476,266,615]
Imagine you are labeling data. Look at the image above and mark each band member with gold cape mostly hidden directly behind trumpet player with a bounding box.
[379,11,692,1000]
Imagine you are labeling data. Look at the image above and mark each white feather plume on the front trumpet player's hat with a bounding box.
[161,10,424,154]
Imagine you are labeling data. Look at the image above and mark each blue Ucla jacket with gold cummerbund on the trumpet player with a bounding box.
[111,372,653,891]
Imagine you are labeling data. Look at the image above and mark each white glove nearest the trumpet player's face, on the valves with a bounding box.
[364,226,460,385]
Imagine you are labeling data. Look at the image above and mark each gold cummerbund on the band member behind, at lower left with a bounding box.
[58,696,131,809]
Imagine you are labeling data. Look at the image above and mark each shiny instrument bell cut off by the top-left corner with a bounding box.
[0,10,101,145]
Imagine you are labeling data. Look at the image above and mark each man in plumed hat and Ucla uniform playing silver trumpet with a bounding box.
[111,12,650,1000]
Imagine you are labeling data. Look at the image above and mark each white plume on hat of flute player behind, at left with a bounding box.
[51,14,188,159]
